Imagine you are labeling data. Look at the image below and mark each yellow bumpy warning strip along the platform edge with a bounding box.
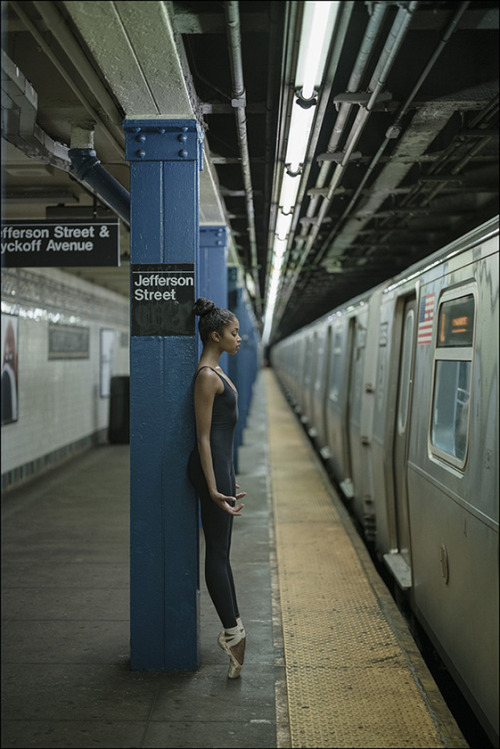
[265,370,467,749]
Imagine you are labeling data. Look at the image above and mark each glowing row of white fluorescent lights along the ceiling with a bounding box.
[262,0,340,345]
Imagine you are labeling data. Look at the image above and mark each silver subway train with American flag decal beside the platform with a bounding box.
[270,217,499,746]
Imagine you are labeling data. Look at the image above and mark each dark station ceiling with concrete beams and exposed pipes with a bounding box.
[2,0,498,340]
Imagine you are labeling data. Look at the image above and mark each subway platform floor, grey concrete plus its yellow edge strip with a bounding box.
[1,369,467,749]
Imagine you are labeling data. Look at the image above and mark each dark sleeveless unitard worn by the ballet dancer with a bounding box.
[188,367,239,629]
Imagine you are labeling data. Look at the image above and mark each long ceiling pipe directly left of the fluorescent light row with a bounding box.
[224,2,262,315]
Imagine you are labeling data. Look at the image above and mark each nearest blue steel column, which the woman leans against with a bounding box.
[123,119,202,670]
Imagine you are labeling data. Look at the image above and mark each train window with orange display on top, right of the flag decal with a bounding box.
[431,292,475,468]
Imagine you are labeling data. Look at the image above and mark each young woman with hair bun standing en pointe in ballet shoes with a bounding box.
[189,298,246,679]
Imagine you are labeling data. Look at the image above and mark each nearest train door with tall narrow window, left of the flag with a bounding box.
[393,297,416,572]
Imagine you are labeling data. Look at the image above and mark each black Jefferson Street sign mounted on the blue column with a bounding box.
[130,263,195,336]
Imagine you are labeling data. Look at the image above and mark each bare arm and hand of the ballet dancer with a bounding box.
[194,369,244,515]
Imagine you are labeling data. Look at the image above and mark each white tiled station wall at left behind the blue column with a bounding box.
[1,268,129,489]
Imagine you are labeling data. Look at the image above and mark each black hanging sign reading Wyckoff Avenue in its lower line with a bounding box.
[0,219,120,268]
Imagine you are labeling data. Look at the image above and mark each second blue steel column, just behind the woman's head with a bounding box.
[198,226,228,371]
